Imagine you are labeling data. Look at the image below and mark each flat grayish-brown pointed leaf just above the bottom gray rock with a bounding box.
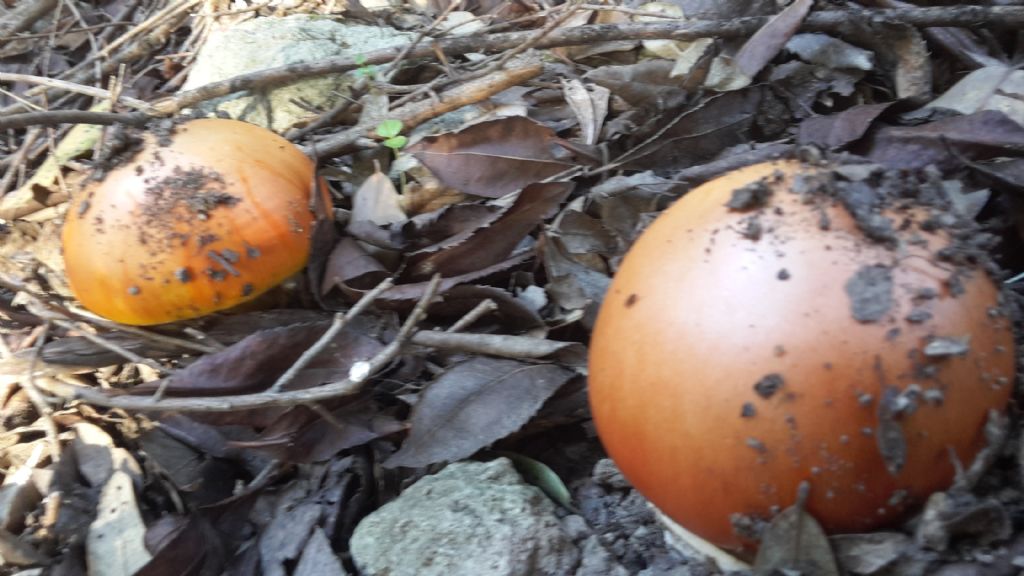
[384,357,573,467]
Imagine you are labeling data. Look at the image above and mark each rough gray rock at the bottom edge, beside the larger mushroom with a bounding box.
[349,458,580,576]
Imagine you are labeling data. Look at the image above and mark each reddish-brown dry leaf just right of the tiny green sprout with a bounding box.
[407,116,573,198]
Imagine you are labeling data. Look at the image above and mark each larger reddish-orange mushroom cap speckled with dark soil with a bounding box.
[589,161,1015,549]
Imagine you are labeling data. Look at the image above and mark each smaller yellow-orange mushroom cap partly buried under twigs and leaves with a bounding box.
[62,119,325,325]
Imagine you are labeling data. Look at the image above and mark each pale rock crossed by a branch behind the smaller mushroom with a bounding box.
[182,14,412,132]
